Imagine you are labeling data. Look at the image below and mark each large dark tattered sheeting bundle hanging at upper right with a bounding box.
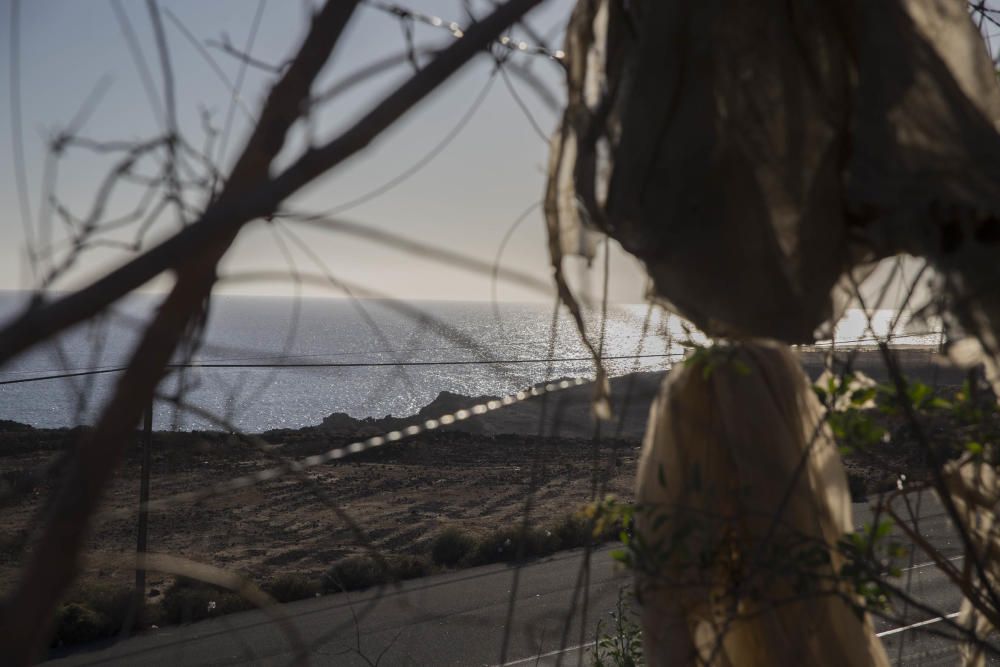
[546,0,1000,395]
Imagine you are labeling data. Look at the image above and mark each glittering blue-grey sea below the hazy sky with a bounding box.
[0,292,940,432]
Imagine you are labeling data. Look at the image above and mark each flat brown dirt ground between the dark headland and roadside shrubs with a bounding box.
[0,424,639,590]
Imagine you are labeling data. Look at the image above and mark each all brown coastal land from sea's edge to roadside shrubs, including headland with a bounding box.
[0,349,964,620]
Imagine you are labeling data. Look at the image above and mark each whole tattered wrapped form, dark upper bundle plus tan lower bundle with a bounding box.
[545,0,1000,665]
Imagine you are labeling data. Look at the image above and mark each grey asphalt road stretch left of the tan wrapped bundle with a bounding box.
[48,549,627,667]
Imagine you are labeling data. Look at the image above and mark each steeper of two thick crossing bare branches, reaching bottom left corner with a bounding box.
[0,1,357,665]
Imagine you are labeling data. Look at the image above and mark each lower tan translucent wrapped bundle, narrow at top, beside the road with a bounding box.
[635,343,888,667]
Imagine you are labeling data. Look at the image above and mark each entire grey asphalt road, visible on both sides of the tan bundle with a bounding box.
[47,496,996,667]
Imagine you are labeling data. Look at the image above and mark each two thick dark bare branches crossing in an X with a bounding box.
[0,0,541,665]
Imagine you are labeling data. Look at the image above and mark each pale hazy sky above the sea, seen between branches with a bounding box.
[0,0,642,302]
